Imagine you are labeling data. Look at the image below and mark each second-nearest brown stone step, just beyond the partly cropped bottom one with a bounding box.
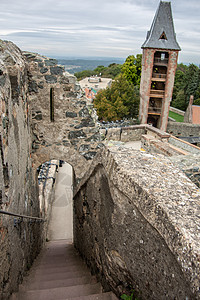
[15,283,102,300]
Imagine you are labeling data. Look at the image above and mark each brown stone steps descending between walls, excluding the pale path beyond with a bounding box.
[10,240,118,300]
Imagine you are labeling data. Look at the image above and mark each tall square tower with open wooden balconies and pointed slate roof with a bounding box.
[139,1,181,131]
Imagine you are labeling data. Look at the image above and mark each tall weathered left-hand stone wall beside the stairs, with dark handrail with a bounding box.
[0,41,43,300]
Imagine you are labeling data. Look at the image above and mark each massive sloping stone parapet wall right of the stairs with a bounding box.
[74,146,200,300]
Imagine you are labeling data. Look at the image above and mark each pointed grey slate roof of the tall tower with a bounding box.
[142,1,181,51]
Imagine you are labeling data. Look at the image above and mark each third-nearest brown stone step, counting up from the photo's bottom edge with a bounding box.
[20,275,97,291]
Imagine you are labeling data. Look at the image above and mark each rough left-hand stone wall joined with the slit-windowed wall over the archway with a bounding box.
[0,41,102,299]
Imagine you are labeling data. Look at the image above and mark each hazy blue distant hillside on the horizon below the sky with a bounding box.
[56,57,125,74]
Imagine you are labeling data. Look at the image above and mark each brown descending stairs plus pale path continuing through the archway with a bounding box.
[10,163,117,300]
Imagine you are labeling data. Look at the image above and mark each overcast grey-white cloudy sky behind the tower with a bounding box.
[0,0,200,64]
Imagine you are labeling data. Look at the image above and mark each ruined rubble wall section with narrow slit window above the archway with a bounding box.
[24,52,102,179]
